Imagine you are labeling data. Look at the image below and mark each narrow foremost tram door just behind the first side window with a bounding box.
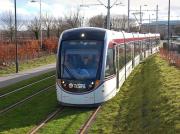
[114,44,119,90]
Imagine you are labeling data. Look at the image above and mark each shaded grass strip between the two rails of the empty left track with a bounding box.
[0,77,55,110]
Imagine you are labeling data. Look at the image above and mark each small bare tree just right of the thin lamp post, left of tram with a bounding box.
[42,13,54,38]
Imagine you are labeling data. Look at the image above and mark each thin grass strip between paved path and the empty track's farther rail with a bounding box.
[0,71,55,95]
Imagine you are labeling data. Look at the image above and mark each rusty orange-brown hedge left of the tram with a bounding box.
[0,38,58,66]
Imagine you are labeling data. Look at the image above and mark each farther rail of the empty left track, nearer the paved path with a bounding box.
[0,75,55,99]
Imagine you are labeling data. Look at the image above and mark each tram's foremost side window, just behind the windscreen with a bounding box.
[105,48,115,77]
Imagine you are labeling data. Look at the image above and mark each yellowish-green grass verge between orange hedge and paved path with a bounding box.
[0,55,56,76]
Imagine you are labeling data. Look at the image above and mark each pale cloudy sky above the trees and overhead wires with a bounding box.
[0,0,180,21]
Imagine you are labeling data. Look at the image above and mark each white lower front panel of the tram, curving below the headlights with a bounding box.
[56,77,117,105]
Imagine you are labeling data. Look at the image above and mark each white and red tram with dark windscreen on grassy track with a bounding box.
[56,27,160,106]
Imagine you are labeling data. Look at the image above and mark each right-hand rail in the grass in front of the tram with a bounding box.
[79,106,101,134]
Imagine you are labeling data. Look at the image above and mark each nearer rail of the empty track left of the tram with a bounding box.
[0,84,55,114]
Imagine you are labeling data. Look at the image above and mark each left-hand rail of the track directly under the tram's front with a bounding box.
[28,107,64,134]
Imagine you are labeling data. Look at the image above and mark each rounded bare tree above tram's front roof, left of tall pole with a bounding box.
[88,14,105,28]
